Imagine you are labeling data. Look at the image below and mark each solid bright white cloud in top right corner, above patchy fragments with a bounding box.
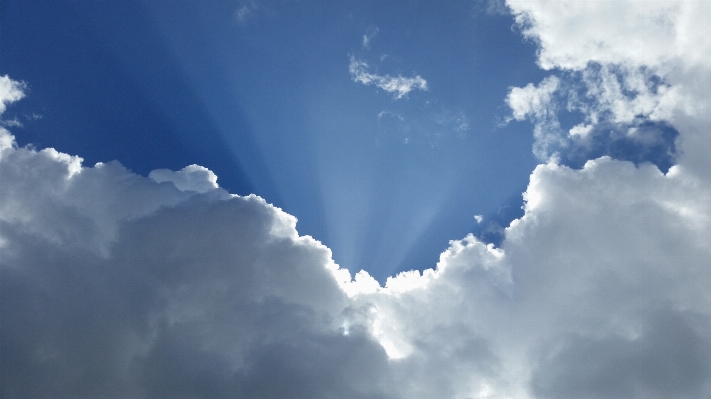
[507,0,711,70]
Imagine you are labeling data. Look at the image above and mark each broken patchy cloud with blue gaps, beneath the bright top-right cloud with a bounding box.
[507,64,682,165]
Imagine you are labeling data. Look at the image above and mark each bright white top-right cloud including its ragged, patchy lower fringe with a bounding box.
[508,0,711,171]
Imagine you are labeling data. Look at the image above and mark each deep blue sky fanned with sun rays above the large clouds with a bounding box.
[1,1,544,279]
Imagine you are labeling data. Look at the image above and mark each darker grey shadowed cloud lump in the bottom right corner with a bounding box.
[531,311,711,398]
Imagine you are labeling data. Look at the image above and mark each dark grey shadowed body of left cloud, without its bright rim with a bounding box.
[0,198,388,398]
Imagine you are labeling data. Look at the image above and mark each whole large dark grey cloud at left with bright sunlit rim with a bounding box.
[0,126,387,398]
